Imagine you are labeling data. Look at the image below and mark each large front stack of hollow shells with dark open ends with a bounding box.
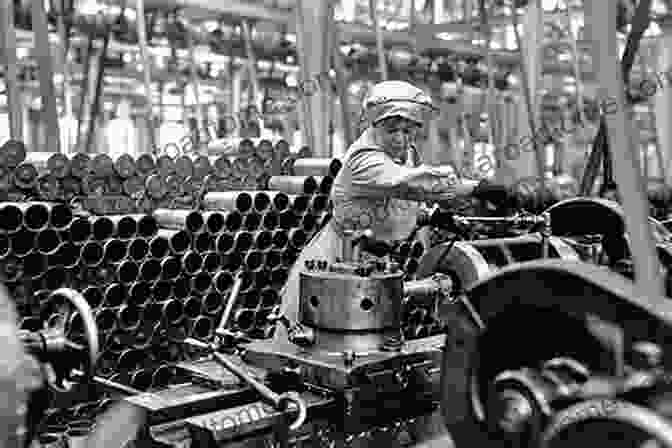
[0,153,436,390]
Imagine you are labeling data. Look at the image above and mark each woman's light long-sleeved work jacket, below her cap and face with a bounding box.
[331,130,468,241]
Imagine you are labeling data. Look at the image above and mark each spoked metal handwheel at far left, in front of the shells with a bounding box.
[36,288,100,392]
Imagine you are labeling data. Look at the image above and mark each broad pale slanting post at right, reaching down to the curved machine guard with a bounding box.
[584,2,665,300]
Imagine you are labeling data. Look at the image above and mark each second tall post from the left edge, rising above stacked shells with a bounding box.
[31,0,61,152]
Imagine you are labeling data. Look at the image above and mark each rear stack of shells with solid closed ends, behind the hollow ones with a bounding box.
[0,140,335,214]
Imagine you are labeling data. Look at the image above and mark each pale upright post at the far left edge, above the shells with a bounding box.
[0,0,23,140]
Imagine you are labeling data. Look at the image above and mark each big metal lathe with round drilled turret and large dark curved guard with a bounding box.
[22,200,672,448]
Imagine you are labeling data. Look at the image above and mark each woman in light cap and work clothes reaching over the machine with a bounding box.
[276,81,508,326]
